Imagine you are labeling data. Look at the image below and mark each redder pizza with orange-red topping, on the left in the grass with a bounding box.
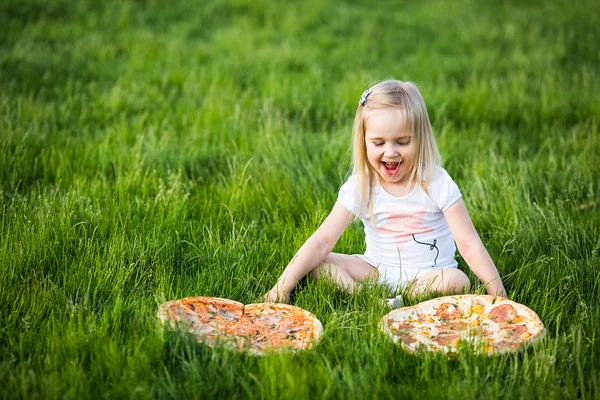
[158,297,323,355]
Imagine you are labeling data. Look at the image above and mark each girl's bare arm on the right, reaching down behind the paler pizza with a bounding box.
[444,199,507,297]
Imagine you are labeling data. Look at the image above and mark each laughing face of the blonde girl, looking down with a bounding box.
[365,108,416,187]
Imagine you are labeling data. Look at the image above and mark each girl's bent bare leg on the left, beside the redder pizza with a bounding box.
[310,253,379,293]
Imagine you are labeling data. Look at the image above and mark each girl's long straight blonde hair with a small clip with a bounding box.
[352,80,442,225]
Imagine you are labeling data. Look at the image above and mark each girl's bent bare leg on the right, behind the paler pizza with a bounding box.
[407,268,471,295]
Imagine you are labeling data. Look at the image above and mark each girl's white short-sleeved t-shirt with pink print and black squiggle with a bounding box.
[338,168,462,284]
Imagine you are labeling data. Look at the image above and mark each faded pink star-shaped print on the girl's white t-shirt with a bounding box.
[377,204,435,251]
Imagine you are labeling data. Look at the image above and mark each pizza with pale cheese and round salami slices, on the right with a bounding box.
[380,295,544,354]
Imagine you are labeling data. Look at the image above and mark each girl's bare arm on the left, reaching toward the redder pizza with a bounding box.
[264,202,354,302]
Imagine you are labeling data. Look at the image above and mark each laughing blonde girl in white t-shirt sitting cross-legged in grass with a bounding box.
[264,80,506,302]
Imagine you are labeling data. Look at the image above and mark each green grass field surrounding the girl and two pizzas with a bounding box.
[0,0,600,399]
